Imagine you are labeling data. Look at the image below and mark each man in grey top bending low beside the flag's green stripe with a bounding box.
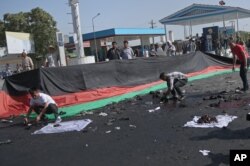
[160,72,188,100]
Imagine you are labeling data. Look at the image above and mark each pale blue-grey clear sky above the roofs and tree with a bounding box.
[0,0,250,39]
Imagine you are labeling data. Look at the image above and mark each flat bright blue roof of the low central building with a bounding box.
[69,28,165,43]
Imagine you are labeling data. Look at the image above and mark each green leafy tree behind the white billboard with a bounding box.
[0,8,57,55]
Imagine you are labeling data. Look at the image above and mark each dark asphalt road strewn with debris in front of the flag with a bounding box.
[0,73,250,166]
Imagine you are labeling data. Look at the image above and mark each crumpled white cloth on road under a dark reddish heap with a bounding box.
[184,115,237,128]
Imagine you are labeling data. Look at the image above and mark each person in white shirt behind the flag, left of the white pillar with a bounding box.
[45,45,59,67]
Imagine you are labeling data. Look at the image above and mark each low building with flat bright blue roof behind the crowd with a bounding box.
[69,28,166,60]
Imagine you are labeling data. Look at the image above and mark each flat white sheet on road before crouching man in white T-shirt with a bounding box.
[32,119,92,134]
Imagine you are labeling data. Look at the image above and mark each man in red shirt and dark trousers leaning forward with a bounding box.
[229,40,249,92]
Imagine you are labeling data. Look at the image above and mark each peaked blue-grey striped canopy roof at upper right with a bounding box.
[160,4,250,26]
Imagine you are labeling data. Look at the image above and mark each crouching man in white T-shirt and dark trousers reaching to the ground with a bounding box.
[24,88,62,124]
